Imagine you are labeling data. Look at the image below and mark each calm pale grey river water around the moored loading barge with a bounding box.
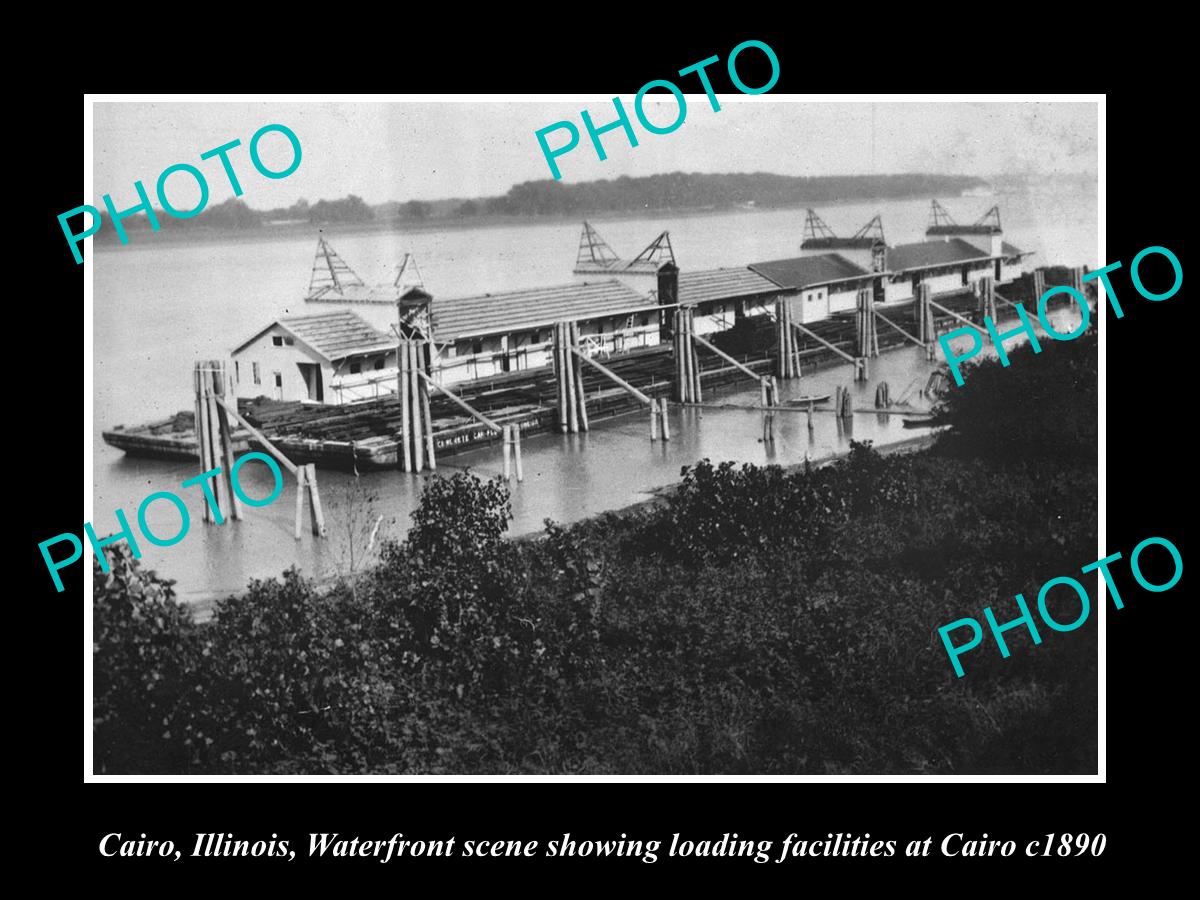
[91,184,1099,601]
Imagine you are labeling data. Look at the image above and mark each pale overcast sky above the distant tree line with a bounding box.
[89,100,1097,209]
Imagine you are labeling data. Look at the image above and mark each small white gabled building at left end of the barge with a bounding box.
[230,310,398,403]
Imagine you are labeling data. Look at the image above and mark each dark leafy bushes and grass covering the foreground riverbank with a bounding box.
[94,335,1097,774]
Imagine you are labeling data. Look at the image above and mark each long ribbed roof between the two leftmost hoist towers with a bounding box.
[430,278,658,341]
